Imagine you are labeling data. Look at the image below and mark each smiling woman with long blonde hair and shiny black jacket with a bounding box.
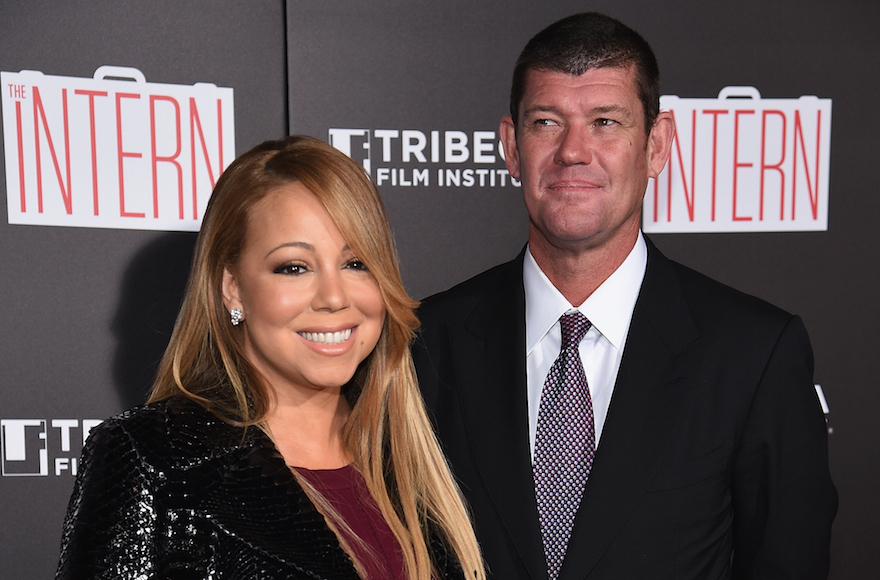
[56,137,485,580]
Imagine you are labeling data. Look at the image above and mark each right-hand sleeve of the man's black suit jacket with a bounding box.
[733,317,837,580]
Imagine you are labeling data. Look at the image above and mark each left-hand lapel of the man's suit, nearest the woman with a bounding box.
[453,253,547,579]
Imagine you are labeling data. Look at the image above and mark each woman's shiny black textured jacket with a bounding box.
[56,399,463,580]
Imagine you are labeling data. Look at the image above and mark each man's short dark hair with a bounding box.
[510,12,660,133]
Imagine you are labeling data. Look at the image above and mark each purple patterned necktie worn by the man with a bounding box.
[533,312,596,580]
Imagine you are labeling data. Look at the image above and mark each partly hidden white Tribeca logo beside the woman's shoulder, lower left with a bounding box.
[0,419,101,477]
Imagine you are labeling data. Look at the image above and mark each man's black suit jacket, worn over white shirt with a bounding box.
[414,242,837,580]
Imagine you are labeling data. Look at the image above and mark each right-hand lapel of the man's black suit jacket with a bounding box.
[560,242,698,580]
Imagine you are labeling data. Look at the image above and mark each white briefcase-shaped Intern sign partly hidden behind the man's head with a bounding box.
[642,87,831,233]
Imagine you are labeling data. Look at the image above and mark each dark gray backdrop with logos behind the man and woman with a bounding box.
[0,0,880,580]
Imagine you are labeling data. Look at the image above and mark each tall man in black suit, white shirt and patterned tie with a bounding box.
[414,14,837,580]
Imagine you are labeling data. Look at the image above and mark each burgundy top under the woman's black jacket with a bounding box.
[295,465,406,580]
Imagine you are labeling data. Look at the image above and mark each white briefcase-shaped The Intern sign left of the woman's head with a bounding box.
[0,66,235,231]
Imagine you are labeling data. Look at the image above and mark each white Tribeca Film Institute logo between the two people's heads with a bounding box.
[329,128,520,187]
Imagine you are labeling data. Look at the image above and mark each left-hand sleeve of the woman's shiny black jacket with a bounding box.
[55,422,160,580]
